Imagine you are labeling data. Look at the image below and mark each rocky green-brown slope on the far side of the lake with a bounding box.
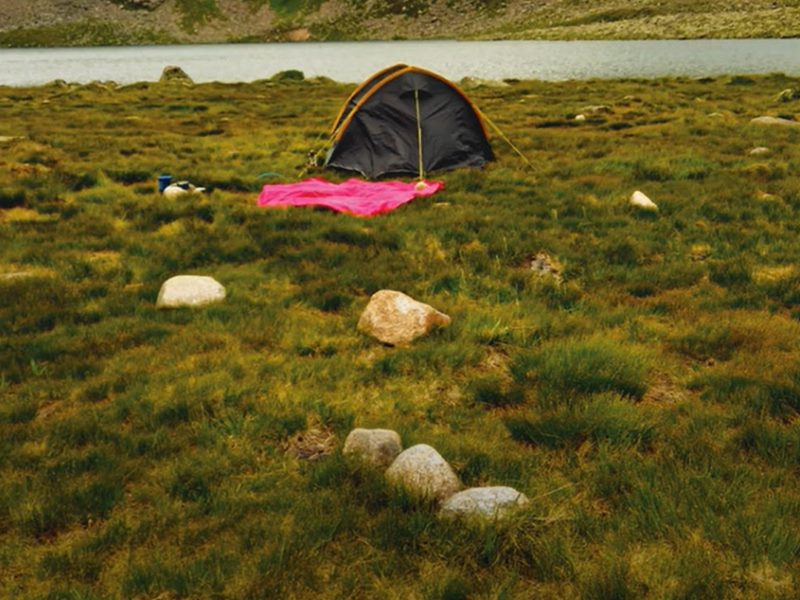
[0,0,800,47]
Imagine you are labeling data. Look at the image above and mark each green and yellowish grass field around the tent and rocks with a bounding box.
[0,75,800,600]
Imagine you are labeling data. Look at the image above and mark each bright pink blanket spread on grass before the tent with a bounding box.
[258,179,444,217]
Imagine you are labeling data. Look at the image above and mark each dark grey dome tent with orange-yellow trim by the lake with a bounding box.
[325,65,494,178]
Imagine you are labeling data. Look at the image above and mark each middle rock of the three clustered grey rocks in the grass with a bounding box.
[386,444,461,501]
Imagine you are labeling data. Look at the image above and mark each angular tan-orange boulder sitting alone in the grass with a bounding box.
[358,290,450,346]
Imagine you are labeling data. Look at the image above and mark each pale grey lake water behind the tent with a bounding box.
[0,39,800,86]
